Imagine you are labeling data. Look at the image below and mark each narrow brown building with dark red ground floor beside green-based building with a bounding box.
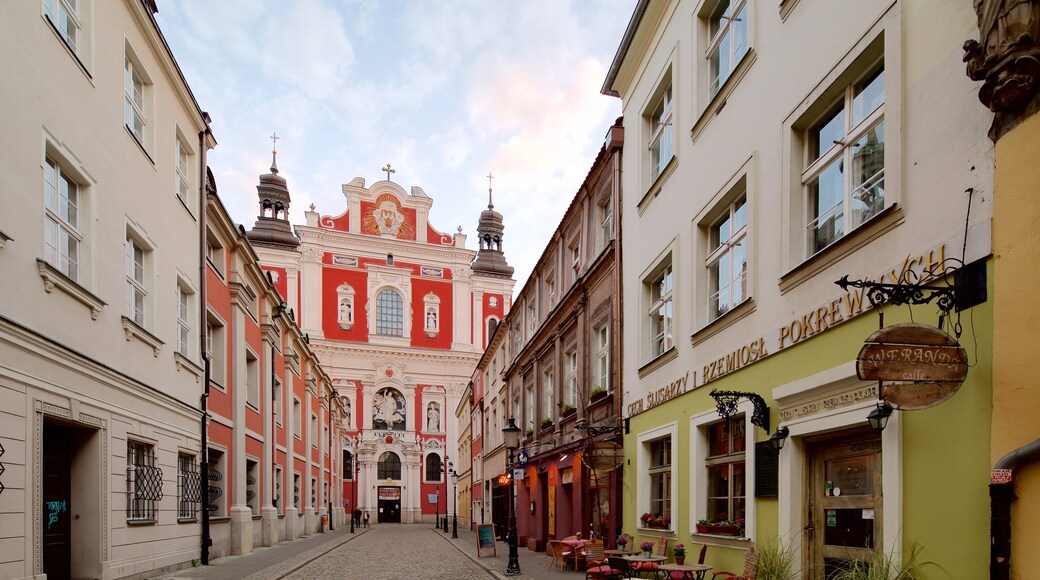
[495,123,624,551]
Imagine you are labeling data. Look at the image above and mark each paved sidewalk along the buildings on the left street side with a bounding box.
[156,525,368,580]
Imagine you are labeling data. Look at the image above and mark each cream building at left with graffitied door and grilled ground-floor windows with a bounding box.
[0,0,215,578]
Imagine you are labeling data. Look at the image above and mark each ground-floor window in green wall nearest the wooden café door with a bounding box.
[704,415,747,528]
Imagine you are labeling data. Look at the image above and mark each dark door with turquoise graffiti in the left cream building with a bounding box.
[40,422,73,578]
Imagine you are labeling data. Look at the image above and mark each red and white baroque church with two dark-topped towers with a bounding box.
[248,156,515,523]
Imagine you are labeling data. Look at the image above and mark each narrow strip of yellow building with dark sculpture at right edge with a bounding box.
[965,0,1040,579]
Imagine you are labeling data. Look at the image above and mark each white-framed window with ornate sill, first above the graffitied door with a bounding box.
[44,157,83,282]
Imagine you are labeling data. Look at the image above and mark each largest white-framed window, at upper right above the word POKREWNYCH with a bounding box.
[802,62,885,256]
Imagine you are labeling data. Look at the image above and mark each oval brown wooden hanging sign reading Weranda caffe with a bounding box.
[856,322,968,411]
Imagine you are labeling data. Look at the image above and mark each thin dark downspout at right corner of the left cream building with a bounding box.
[199,119,213,565]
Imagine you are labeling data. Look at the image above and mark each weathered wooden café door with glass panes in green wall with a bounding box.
[805,429,883,580]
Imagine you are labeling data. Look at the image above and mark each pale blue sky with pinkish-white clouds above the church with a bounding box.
[156,0,635,292]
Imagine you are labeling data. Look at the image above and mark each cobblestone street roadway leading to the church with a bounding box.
[286,524,494,580]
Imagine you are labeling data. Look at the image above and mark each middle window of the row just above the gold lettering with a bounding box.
[706,194,748,321]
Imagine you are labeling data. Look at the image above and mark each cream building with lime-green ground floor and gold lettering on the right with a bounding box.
[607,0,993,578]
